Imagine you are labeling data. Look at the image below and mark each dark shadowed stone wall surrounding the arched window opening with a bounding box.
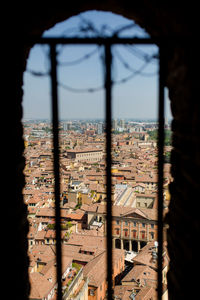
[10,0,200,300]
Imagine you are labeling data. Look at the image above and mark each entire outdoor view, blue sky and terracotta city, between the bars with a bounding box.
[23,11,172,300]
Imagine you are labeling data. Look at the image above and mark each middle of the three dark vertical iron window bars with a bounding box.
[105,43,113,299]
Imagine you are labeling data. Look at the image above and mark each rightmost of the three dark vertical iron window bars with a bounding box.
[158,45,165,300]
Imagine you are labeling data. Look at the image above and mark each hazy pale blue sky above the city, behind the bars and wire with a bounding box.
[23,11,171,119]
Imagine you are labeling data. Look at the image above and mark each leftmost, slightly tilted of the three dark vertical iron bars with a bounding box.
[50,43,62,300]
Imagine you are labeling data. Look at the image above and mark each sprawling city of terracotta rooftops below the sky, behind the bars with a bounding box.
[23,119,172,300]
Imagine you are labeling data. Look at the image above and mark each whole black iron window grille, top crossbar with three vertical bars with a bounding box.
[34,37,164,300]
